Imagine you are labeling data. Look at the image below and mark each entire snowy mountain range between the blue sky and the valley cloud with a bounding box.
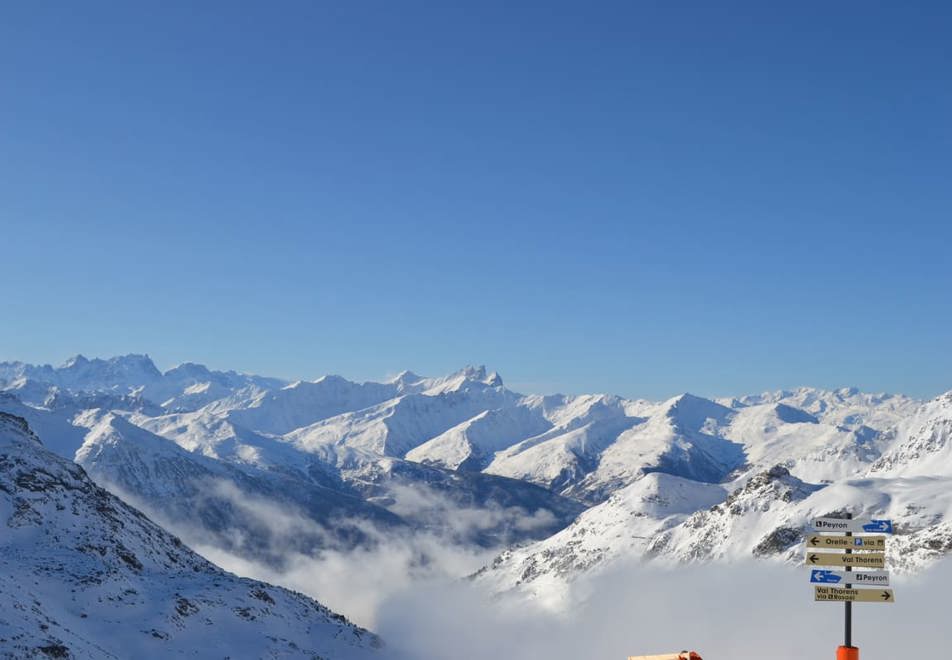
[0,356,952,612]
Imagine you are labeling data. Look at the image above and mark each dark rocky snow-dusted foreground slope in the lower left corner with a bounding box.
[0,413,384,660]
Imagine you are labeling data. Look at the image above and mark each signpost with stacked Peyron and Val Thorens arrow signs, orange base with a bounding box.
[806,513,896,660]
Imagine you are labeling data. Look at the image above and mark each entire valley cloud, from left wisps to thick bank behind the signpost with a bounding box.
[100,474,952,660]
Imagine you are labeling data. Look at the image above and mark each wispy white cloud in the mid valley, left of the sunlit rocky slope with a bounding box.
[121,480,498,629]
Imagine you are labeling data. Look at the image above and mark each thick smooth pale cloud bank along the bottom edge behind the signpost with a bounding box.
[377,561,952,660]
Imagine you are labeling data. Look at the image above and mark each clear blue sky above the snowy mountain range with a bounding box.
[0,0,952,398]
